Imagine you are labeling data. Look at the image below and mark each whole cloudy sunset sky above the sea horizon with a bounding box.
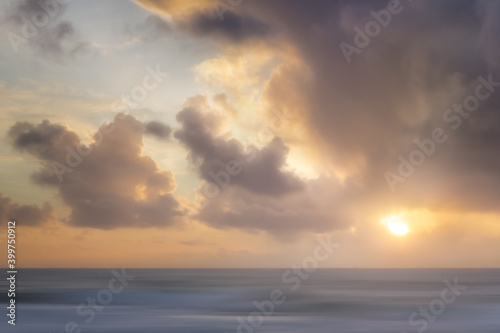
[0,0,500,268]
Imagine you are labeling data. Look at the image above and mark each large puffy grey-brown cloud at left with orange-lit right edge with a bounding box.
[8,114,180,229]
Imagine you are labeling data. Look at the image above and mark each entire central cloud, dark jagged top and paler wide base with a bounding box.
[174,96,354,238]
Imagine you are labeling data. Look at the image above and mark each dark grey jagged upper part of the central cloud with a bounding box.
[174,95,304,196]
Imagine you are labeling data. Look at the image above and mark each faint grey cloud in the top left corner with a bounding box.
[3,0,88,61]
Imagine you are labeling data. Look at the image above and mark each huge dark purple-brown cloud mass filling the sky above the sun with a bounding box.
[229,0,500,211]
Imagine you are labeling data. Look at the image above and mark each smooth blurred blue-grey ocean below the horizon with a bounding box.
[0,268,500,333]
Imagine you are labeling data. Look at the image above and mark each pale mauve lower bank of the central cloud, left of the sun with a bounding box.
[194,179,358,239]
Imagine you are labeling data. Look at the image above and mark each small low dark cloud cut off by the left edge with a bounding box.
[0,194,53,226]
